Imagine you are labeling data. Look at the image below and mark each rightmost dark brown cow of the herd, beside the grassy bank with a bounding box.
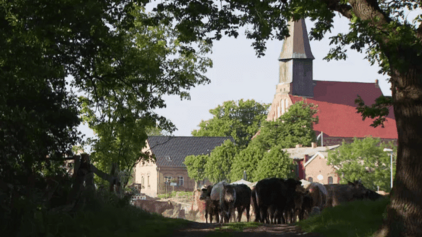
[324,181,369,207]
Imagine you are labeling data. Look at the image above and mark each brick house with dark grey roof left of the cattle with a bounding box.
[134,136,234,197]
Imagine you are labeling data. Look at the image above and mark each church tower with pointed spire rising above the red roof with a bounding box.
[277,19,315,97]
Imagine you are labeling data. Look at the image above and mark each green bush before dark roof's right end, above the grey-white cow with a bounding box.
[205,140,238,183]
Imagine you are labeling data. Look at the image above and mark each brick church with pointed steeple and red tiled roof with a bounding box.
[267,19,398,146]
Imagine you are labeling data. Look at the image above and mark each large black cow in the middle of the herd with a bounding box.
[254,178,301,223]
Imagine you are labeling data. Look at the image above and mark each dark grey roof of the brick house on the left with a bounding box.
[148,136,234,167]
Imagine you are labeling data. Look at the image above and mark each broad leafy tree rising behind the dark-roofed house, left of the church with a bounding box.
[192,99,269,148]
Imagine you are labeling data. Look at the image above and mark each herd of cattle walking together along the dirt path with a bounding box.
[200,178,383,224]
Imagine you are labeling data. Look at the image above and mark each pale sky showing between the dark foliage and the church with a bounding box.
[79,8,421,143]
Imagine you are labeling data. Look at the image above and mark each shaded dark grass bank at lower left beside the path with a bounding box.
[11,191,190,237]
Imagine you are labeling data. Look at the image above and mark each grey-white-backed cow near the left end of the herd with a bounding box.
[210,181,236,223]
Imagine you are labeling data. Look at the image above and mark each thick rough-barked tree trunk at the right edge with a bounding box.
[376,62,422,236]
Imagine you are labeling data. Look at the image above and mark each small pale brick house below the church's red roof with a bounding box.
[283,142,340,184]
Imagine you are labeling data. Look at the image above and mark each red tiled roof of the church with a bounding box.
[290,81,398,139]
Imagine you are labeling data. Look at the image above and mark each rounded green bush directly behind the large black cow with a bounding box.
[253,145,295,181]
